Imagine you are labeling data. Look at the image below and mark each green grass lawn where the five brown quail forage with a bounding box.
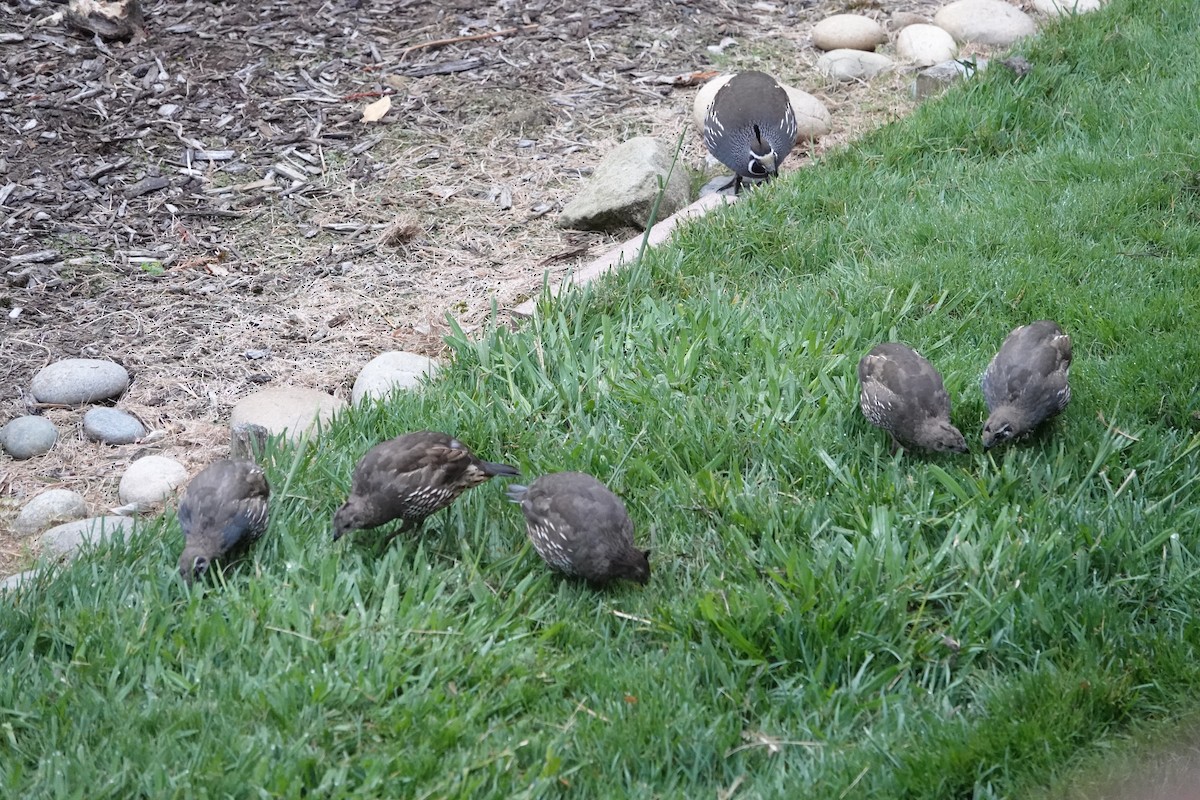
[0,0,1200,799]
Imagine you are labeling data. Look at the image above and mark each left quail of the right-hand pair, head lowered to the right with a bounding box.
[858,342,967,452]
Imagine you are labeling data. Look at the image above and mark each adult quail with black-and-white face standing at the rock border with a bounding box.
[703,71,796,192]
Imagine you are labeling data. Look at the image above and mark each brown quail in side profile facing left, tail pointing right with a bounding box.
[334,431,521,541]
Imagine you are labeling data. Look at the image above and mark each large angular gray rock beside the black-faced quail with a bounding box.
[558,137,690,230]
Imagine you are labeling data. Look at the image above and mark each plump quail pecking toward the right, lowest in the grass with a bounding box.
[509,473,650,587]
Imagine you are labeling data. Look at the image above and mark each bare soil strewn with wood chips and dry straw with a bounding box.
[0,0,974,575]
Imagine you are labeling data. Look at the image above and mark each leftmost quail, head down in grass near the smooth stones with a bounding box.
[178,459,271,583]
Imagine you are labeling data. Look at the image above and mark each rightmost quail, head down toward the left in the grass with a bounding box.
[979,319,1070,449]
